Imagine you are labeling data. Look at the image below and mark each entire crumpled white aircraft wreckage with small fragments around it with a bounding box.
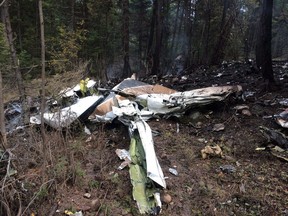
[20,78,242,214]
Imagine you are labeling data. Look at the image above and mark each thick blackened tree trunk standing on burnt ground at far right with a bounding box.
[256,0,275,84]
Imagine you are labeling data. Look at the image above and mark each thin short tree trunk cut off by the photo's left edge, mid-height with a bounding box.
[0,69,7,150]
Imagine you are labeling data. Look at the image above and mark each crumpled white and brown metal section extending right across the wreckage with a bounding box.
[89,79,242,121]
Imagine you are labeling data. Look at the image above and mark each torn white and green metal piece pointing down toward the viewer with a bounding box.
[129,119,166,215]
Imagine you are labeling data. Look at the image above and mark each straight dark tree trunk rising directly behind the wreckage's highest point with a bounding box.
[122,0,131,78]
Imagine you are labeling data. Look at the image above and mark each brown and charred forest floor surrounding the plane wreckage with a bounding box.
[2,62,288,216]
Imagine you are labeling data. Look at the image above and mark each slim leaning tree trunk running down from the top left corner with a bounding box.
[1,0,29,124]
